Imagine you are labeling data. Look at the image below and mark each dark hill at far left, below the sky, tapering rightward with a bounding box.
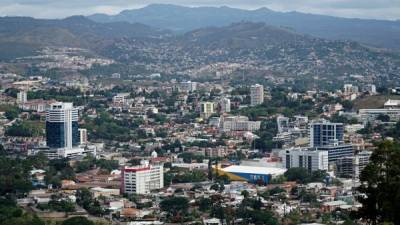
[0,16,168,59]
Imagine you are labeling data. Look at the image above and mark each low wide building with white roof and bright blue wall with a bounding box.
[213,165,286,184]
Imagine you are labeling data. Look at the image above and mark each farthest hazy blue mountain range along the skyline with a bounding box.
[88,4,400,50]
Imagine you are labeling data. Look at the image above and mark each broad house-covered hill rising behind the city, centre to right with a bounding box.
[99,22,400,85]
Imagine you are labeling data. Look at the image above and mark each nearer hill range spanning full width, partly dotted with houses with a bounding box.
[0,13,400,85]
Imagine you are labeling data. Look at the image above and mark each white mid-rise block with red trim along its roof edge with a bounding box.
[121,161,164,194]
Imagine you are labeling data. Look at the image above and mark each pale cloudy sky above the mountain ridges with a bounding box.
[0,0,400,19]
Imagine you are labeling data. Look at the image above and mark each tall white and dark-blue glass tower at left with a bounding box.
[46,102,79,149]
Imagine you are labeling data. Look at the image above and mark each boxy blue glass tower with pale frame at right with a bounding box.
[310,120,344,147]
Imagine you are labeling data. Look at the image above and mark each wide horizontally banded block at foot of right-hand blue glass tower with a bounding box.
[315,143,354,164]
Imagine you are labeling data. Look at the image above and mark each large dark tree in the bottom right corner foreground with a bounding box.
[358,141,400,225]
